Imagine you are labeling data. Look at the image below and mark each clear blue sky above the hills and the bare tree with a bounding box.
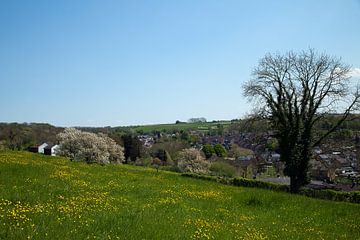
[0,0,360,126]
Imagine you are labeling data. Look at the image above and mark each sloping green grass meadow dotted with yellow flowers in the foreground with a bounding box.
[0,152,360,239]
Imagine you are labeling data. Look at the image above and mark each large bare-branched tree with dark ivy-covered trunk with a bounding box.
[243,49,360,193]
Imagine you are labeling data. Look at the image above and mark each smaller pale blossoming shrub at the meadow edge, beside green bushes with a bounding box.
[178,148,210,174]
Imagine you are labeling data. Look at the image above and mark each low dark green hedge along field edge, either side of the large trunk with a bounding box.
[182,173,360,203]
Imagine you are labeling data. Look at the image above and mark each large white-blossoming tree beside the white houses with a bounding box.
[57,128,124,164]
